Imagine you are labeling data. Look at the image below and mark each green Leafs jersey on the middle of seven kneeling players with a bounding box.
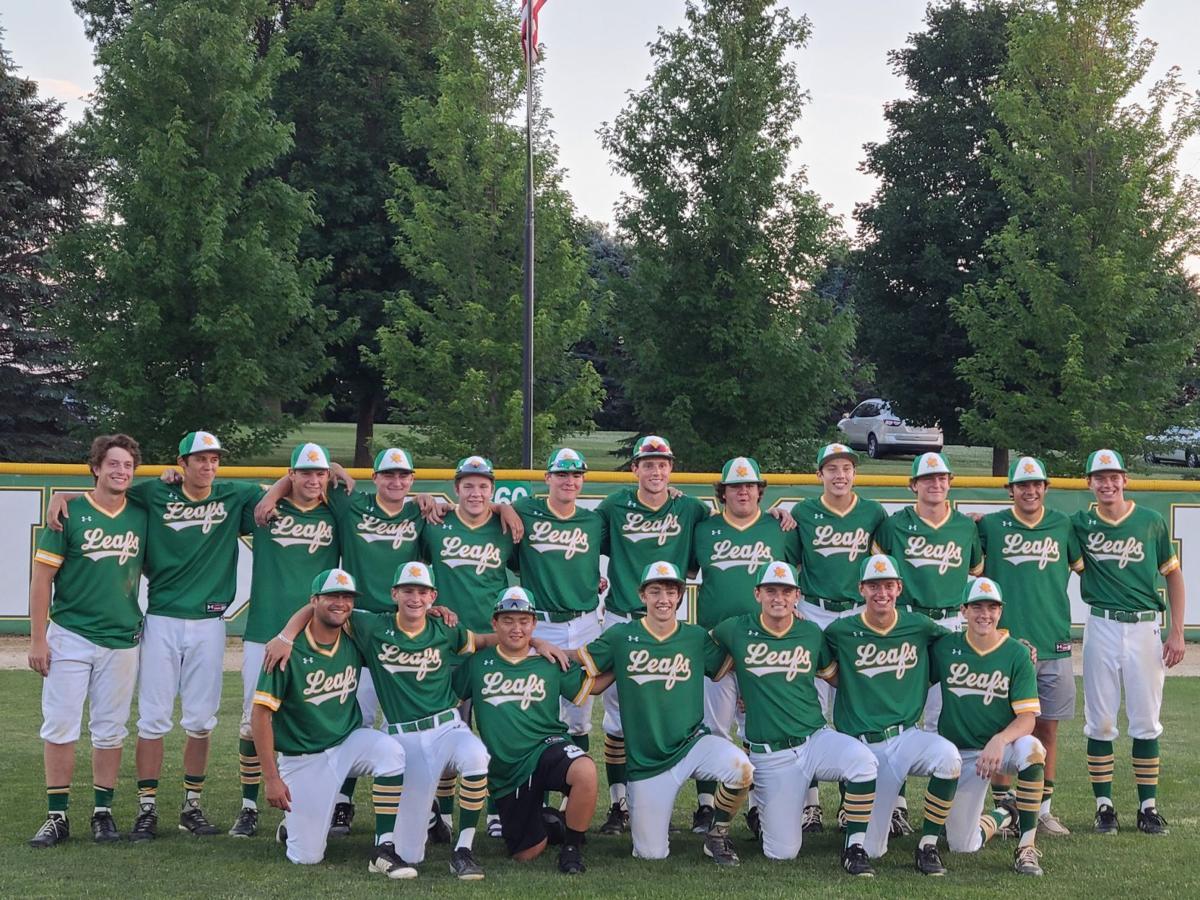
[578,618,726,781]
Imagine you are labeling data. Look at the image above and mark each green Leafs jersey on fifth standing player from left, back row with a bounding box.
[420,510,515,634]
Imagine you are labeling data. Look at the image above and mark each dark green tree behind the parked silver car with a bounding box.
[854,0,1012,458]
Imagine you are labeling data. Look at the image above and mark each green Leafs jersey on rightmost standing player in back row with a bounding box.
[1072,503,1180,612]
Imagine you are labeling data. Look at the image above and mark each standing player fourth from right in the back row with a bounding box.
[792,444,892,833]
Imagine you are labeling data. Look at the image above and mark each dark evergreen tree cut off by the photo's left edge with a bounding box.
[0,31,88,462]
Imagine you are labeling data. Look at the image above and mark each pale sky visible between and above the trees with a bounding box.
[0,0,1200,233]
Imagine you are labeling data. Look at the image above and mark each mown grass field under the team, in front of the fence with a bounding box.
[0,671,1200,900]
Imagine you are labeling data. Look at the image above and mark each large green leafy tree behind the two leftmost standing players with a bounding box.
[56,0,325,458]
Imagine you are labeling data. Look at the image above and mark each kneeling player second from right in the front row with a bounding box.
[817,554,961,875]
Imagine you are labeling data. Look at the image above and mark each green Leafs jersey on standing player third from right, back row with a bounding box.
[875,506,983,610]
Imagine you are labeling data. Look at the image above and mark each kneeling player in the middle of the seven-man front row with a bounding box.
[578,560,754,866]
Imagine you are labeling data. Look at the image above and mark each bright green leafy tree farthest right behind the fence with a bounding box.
[954,0,1200,462]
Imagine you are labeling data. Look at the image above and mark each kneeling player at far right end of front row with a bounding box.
[931,578,1045,875]
